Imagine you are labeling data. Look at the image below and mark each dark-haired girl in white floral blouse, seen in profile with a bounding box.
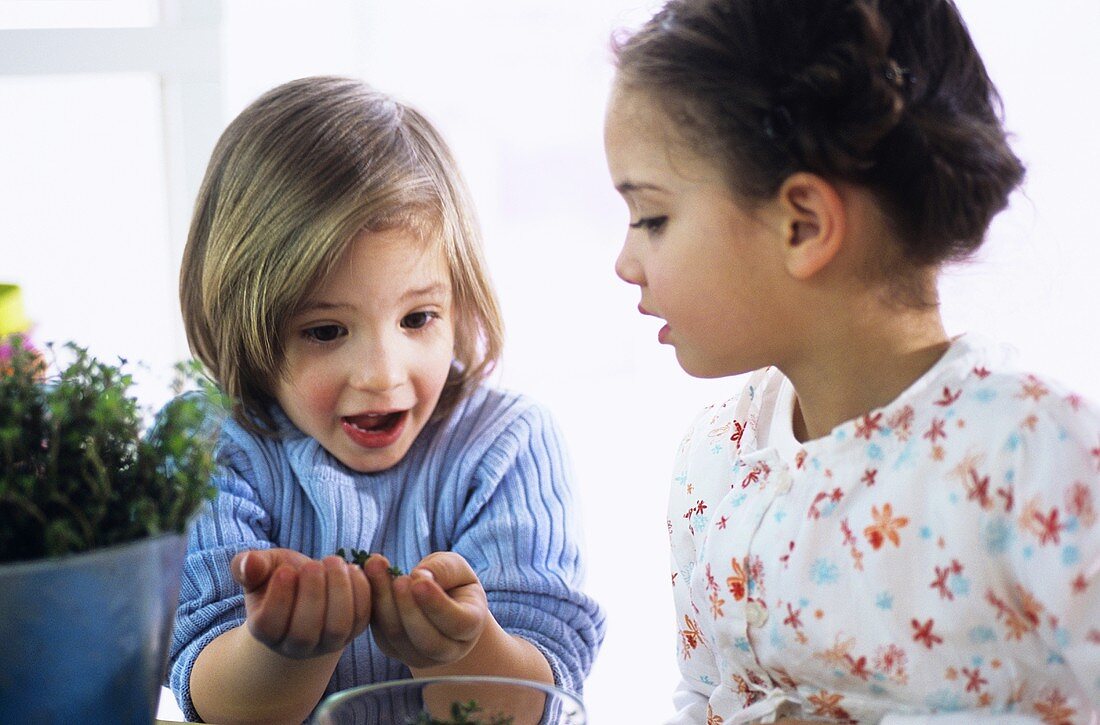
[606,0,1100,725]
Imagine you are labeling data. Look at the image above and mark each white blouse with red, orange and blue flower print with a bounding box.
[668,336,1100,725]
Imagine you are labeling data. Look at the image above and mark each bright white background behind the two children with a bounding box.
[0,0,1100,724]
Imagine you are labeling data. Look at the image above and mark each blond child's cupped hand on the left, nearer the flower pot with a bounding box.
[231,549,371,659]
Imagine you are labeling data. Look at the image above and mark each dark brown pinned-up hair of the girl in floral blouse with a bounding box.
[614,0,1024,266]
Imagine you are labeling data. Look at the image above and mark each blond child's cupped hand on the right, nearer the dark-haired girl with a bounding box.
[363,551,492,668]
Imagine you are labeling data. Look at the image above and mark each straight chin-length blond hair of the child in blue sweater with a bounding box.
[179,77,503,431]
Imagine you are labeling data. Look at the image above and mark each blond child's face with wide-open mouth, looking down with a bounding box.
[275,229,454,473]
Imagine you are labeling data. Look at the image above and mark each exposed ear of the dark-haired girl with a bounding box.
[778,172,847,279]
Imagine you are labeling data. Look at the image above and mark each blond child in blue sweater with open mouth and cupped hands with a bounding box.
[169,77,603,723]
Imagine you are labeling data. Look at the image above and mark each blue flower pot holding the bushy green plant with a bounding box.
[0,535,187,725]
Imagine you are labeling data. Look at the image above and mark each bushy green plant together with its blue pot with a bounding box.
[0,336,213,723]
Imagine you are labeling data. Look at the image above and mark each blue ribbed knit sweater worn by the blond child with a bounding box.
[168,387,604,719]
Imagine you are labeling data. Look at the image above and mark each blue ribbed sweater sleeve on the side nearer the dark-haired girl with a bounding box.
[452,406,604,693]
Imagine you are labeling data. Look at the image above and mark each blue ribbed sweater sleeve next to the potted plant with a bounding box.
[168,433,279,722]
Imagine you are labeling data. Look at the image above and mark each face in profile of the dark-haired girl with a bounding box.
[604,86,788,377]
